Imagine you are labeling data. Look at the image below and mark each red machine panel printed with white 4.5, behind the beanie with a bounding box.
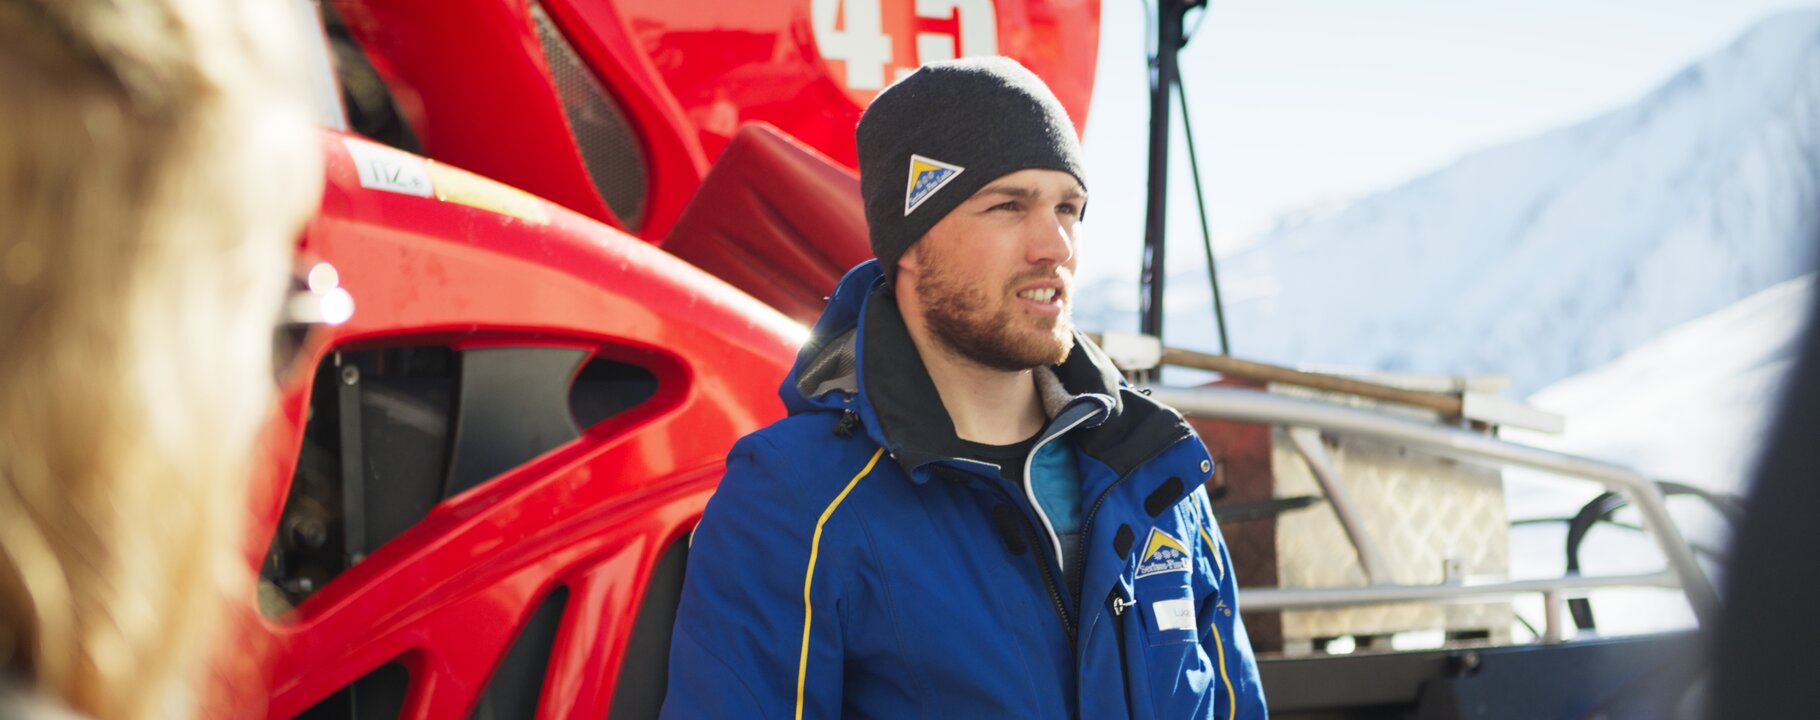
[604,0,1099,167]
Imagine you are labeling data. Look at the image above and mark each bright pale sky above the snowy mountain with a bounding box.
[1081,0,1820,282]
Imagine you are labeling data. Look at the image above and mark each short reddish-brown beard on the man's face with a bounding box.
[915,264,1074,373]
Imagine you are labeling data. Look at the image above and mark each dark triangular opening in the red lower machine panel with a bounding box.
[260,345,657,616]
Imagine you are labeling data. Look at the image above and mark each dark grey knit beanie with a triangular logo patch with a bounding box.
[854,58,1087,278]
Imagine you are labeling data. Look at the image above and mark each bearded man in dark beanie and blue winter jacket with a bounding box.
[664,58,1265,720]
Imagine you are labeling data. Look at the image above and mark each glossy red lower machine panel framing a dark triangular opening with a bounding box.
[253,133,803,718]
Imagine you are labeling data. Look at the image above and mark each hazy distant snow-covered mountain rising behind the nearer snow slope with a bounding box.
[1076,11,1820,396]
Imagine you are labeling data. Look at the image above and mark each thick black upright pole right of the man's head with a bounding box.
[1139,0,1187,338]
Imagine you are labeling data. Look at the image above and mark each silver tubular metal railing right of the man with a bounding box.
[1150,385,1718,642]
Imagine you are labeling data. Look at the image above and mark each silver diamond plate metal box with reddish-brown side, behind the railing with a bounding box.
[1198,385,1514,655]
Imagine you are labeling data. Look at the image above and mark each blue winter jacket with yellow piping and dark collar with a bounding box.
[662,262,1265,720]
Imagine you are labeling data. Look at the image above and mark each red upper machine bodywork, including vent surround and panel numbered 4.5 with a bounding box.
[331,0,1099,242]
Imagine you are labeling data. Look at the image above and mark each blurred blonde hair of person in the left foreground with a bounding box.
[0,0,322,718]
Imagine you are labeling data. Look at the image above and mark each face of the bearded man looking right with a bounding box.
[899,169,1087,371]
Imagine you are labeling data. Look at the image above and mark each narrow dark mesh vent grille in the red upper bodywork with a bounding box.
[531,2,648,231]
